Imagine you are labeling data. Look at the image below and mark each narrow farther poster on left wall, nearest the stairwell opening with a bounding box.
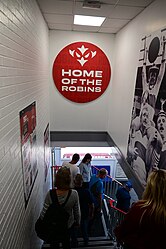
[44,124,51,181]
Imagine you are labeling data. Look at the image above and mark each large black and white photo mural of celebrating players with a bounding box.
[127,28,166,186]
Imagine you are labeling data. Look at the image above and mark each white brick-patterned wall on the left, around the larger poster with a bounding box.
[0,0,49,249]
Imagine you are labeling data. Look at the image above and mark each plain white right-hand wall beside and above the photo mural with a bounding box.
[108,0,166,156]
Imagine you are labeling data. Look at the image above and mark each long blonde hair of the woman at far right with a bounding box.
[142,169,166,226]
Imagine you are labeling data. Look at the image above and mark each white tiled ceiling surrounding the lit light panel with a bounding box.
[37,0,154,34]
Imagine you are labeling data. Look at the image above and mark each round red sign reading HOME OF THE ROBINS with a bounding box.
[53,42,111,103]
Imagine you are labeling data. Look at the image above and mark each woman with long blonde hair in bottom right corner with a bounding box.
[114,169,166,249]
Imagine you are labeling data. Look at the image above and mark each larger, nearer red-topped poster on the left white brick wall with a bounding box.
[20,102,38,207]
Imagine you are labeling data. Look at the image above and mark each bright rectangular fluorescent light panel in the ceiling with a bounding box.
[74,15,105,26]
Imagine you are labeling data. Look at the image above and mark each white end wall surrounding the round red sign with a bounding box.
[49,30,115,131]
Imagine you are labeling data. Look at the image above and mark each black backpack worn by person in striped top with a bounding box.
[35,189,71,242]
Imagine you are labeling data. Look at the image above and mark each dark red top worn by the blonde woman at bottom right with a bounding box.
[114,203,166,249]
